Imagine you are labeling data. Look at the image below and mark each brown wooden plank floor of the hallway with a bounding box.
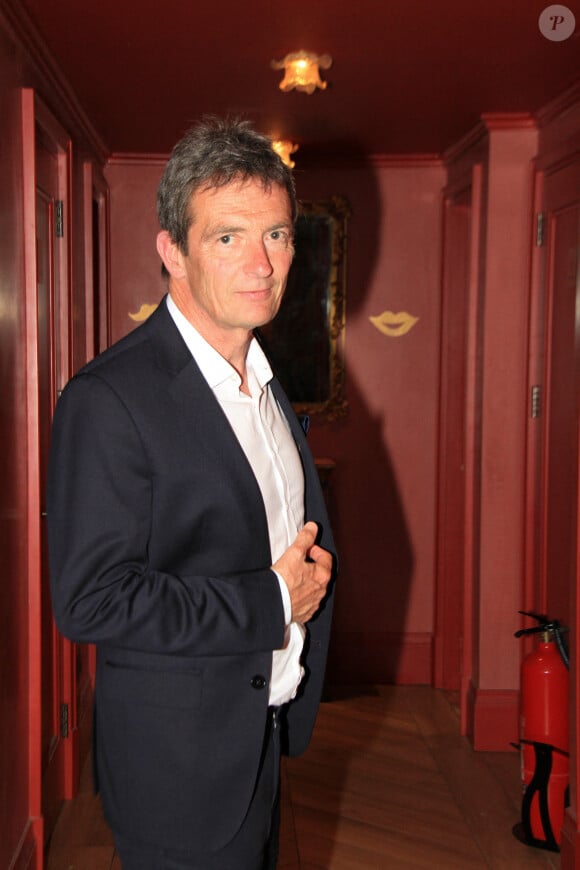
[47,686,560,870]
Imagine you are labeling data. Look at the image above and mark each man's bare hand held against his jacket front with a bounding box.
[272,522,332,622]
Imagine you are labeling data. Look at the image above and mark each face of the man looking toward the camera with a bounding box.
[172,179,294,341]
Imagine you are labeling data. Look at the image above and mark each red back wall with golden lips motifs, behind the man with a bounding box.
[106,158,444,683]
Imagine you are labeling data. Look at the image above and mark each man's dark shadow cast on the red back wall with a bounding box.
[297,146,414,687]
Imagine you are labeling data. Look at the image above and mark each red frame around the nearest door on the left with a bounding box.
[21,88,78,870]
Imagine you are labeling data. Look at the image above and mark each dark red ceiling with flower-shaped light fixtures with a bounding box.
[20,0,580,154]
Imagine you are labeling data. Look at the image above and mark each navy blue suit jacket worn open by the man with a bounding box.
[48,302,334,849]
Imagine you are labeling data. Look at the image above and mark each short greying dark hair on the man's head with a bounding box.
[157,117,296,254]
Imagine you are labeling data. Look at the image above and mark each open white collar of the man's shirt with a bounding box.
[167,294,273,390]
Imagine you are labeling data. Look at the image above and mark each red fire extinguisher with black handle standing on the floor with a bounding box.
[514,610,570,852]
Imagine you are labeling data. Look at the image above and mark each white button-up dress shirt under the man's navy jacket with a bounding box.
[167,295,305,706]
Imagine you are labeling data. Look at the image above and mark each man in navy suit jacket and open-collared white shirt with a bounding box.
[48,120,334,870]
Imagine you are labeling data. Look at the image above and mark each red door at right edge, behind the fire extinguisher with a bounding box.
[537,157,580,867]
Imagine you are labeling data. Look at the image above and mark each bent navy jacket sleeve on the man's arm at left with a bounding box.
[47,375,284,656]
